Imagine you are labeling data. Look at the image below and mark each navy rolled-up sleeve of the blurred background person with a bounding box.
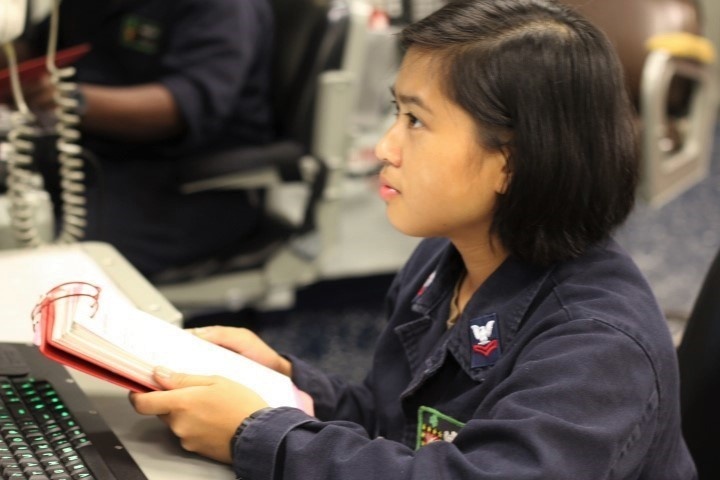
[159,0,273,148]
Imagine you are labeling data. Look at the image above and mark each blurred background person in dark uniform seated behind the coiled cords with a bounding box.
[11,0,274,277]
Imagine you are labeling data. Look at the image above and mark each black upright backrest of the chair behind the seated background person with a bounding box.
[272,0,348,149]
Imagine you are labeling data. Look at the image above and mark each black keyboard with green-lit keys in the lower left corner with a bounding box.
[0,343,147,480]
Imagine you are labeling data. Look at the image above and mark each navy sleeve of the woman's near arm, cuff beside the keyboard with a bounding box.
[233,319,688,480]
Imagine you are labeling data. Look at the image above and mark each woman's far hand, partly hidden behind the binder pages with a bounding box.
[189,326,292,377]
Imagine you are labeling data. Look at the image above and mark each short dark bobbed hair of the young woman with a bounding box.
[400,0,639,265]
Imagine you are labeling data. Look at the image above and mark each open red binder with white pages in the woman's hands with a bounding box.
[32,282,312,411]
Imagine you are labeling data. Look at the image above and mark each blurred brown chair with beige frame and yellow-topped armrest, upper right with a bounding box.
[563,0,718,207]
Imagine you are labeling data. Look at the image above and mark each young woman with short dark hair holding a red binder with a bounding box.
[132,0,696,480]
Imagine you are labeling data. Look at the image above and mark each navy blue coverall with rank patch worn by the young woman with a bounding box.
[233,239,696,480]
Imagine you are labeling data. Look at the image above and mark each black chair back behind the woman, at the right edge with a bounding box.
[677,246,720,480]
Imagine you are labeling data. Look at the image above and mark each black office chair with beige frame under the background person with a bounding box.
[151,0,411,316]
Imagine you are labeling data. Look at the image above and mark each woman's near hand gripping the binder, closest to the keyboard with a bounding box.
[130,367,268,463]
